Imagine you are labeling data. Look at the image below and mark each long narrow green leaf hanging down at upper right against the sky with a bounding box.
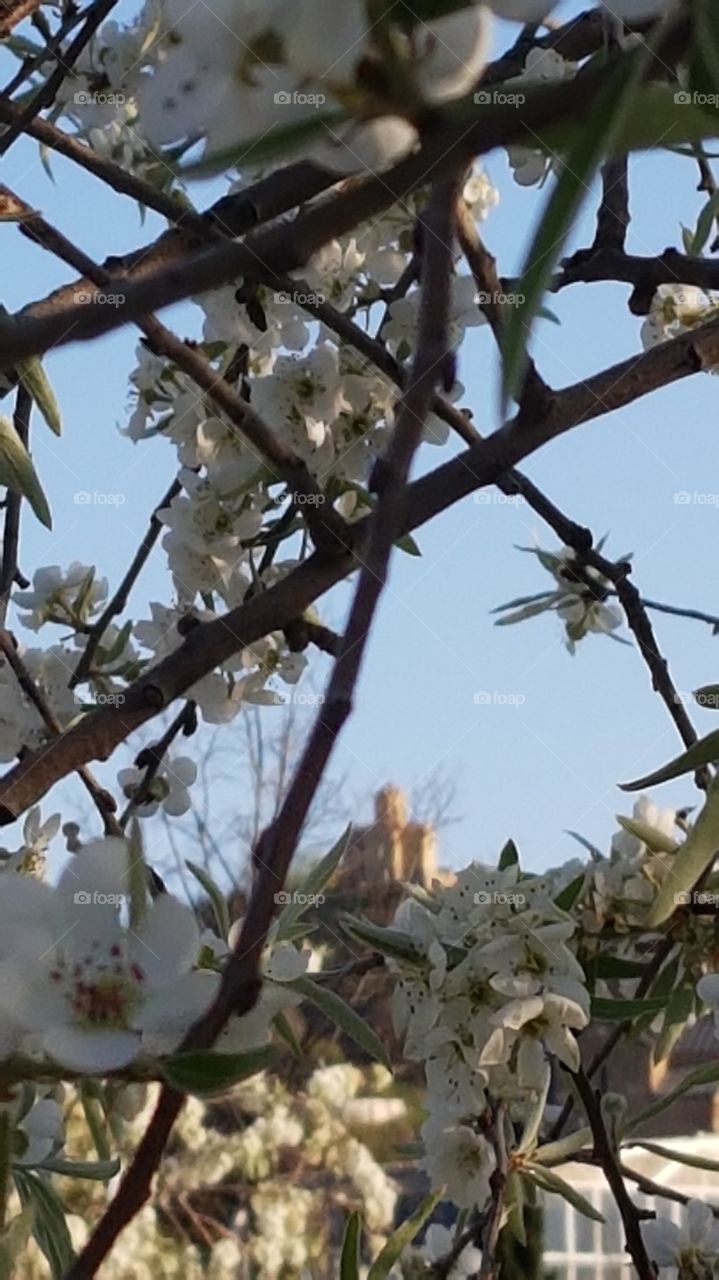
[502,46,651,408]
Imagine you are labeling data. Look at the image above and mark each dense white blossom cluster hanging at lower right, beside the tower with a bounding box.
[380,863,589,1210]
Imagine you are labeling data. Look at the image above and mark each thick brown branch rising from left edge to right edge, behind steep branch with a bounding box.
[0,311,719,826]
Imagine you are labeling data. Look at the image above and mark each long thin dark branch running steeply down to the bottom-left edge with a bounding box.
[67,172,454,1280]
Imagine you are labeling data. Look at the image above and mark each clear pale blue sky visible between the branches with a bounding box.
[0,5,719,869]
